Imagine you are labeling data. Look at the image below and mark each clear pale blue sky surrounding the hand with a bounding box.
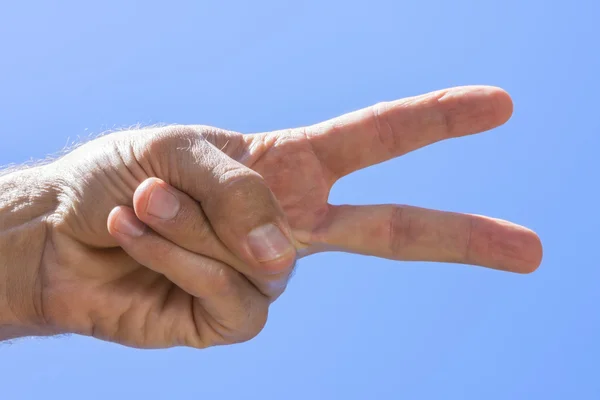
[0,0,600,400]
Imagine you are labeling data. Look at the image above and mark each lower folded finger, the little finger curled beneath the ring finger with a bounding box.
[108,207,269,342]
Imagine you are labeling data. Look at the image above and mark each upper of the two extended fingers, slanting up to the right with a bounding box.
[305,86,513,180]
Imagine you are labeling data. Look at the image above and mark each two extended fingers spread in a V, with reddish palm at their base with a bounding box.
[234,87,542,273]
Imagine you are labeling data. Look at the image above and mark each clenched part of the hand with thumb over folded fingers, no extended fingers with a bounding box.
[24,127,296,348]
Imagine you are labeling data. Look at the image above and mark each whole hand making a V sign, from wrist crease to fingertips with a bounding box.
[1,87,542,347]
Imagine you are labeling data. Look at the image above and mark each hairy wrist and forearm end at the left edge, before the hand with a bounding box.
[0,167,57,340]
